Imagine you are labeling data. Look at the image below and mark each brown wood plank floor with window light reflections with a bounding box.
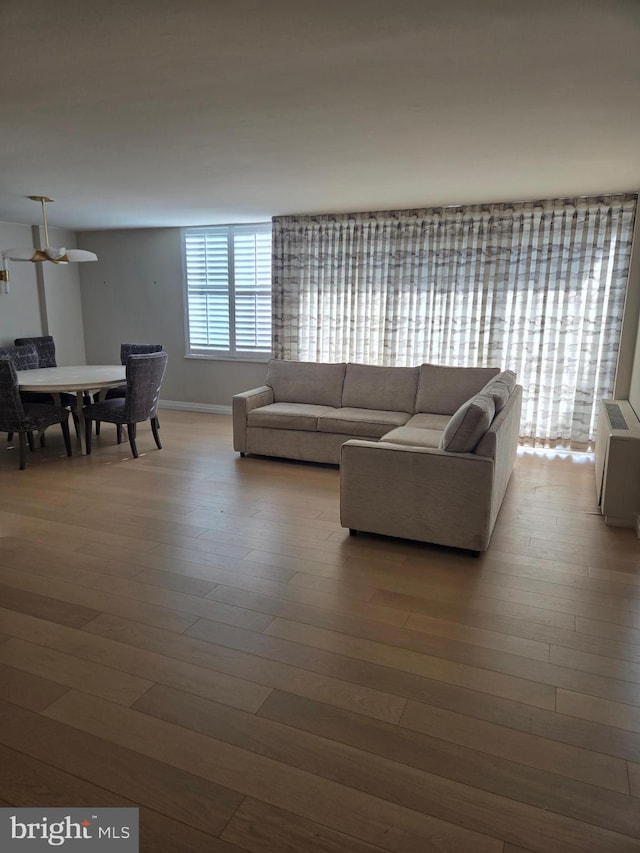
[0,411,640,853]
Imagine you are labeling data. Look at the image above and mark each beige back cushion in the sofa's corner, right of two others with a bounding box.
[415,364,500,415]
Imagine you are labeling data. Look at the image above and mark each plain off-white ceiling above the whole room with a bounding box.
[0,0,640,231]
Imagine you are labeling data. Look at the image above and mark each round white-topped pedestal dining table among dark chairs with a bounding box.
[18,364,126,455]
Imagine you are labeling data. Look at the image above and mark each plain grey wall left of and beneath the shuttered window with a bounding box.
[78,228,266,410]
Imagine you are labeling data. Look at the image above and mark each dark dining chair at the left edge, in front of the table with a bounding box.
[0,356,71,471]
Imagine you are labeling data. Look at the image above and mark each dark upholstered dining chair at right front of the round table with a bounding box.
[83,350,168,459]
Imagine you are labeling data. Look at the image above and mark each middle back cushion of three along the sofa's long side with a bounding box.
[342,364,420,413]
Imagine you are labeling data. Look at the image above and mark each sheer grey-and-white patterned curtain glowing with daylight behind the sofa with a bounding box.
[273,194,637,443]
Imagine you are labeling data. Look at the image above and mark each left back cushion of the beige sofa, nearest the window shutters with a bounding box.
[267,359,346,408]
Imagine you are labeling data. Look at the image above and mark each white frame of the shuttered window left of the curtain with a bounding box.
[181,220,273,364]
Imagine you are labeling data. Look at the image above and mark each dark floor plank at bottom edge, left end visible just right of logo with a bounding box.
[222,797,384,853]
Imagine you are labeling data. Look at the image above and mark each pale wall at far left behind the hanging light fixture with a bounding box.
[0,222,85,365]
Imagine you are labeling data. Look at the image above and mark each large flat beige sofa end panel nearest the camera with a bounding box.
[340,440,494,551]
